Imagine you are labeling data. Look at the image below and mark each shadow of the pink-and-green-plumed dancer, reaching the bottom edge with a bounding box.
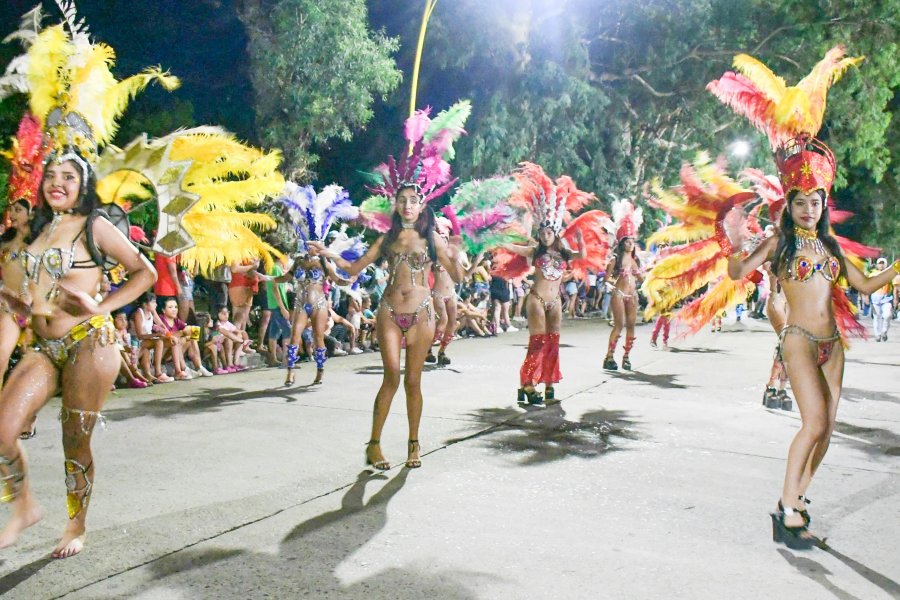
[121,469,489,600]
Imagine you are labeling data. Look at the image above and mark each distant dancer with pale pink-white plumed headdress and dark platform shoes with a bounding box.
[603,200,644,371]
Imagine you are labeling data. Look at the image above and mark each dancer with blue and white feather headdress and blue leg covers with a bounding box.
[275,181,358,386]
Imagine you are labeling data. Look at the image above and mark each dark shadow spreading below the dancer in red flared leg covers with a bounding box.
[446,404,639,466]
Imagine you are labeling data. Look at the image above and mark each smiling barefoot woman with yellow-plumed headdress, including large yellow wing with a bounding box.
[0,5,283,558]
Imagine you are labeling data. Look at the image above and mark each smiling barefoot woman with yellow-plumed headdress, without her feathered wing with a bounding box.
[0,18,174,558]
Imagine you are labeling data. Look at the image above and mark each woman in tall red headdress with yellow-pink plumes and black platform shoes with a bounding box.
[708,47,900,549]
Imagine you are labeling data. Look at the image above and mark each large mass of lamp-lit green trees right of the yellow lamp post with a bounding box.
[398,0,900,248]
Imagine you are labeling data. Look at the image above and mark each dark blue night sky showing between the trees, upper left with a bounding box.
[0,0,428,187]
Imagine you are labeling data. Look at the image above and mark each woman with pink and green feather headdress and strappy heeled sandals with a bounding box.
[309,102,471,471]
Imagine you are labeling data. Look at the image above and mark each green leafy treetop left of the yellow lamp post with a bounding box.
[240,0,401,173]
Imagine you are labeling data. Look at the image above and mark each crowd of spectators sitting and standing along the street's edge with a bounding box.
[100,250,624,388]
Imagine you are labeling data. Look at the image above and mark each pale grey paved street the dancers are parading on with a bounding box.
[0,320,900,600]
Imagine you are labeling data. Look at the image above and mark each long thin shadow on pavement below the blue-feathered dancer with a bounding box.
[103,384,310,421]
